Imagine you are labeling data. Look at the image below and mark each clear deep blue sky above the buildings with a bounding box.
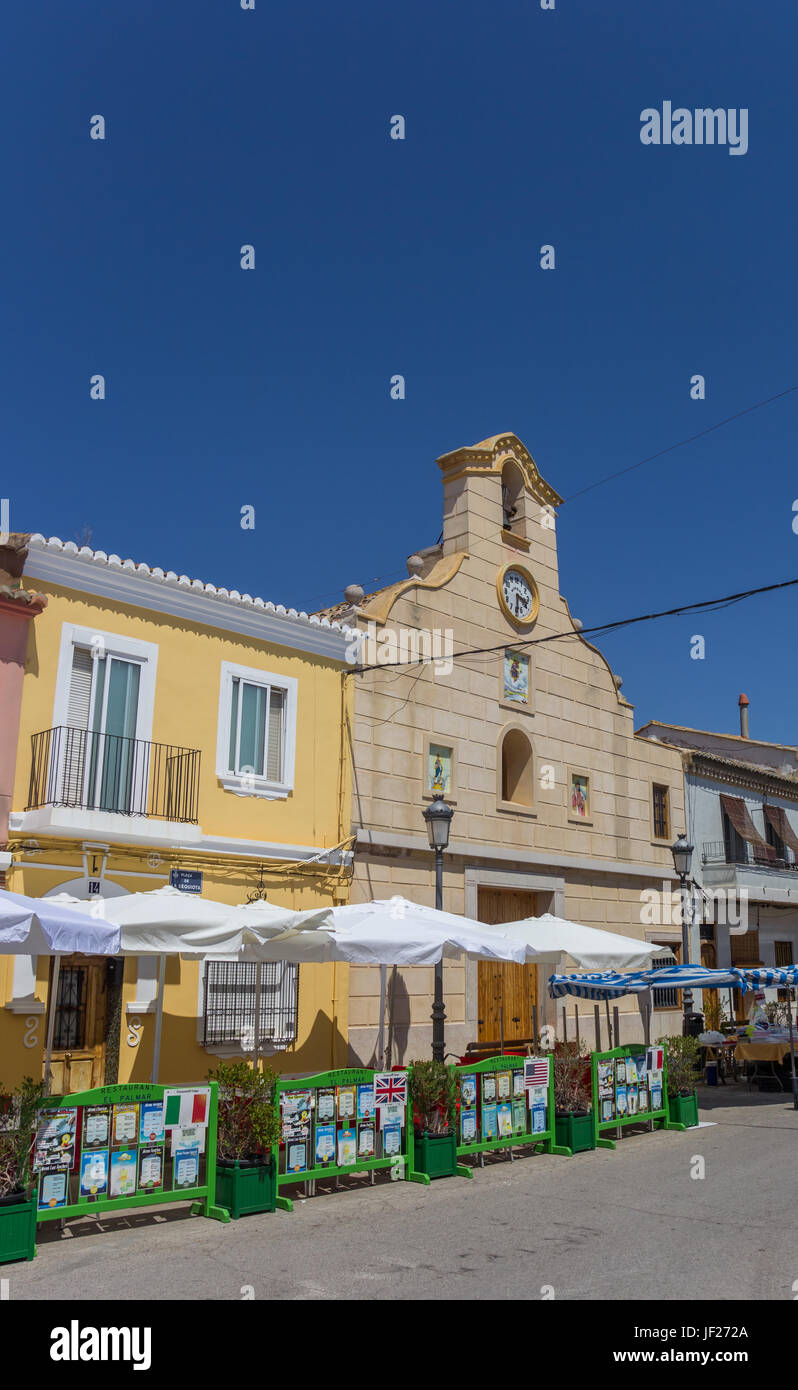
[6,0,798,742]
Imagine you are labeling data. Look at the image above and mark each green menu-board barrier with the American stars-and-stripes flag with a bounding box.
[455,1056,571,1177]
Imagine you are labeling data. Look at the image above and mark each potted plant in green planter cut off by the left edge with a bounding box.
[0,1076,44,1265]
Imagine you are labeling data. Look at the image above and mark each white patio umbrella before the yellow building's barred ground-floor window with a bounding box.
[47,884,331,1081]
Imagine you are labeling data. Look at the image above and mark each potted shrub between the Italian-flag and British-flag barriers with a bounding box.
[209,1062,279,1220]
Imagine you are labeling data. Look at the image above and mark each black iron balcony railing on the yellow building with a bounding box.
[25,726,200,826]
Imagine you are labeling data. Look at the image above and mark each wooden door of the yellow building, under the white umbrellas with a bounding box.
[50,955,108,1095]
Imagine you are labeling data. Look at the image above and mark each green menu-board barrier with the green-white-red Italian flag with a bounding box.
[33,1083,229,1222]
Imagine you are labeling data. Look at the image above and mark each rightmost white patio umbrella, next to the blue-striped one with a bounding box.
[485,912,663,970]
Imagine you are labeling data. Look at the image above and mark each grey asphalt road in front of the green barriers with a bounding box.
[7,1086,798,1301]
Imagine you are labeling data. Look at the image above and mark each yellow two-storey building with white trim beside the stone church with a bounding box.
[0,535,352,1091]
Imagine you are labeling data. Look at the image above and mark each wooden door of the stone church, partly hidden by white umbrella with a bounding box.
[477,888,542,1043]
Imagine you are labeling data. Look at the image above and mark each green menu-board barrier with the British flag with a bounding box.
[274,1068,428,1212]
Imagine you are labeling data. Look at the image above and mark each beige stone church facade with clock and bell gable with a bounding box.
[326,434,684,1062]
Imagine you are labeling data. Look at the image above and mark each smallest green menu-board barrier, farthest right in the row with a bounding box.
[591,1043,687,1148]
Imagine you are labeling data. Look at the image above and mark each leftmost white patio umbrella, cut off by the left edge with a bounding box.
[0,888,120,1091]
